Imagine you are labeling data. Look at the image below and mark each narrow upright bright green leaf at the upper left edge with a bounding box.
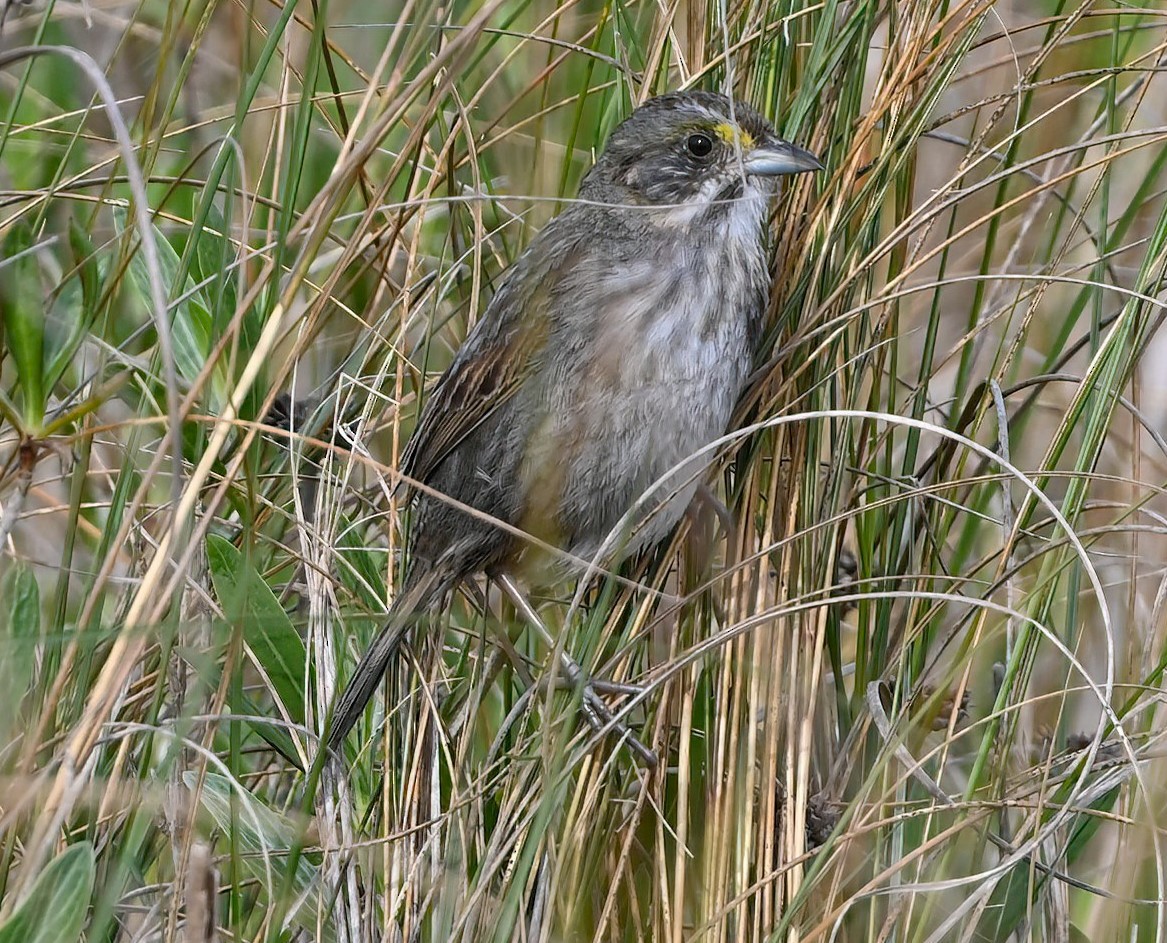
[0,219,44,434]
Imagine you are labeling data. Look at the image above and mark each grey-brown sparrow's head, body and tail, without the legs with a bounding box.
[328,92,818,747]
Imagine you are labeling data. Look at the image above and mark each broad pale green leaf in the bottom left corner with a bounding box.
[0,841,95,943]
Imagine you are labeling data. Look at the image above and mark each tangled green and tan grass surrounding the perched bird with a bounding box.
[0,0,1167,943]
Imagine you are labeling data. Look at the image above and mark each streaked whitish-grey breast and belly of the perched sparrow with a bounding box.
[524,221,768,558]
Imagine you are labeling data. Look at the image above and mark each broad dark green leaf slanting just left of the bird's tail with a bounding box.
[207,535,307,724]
